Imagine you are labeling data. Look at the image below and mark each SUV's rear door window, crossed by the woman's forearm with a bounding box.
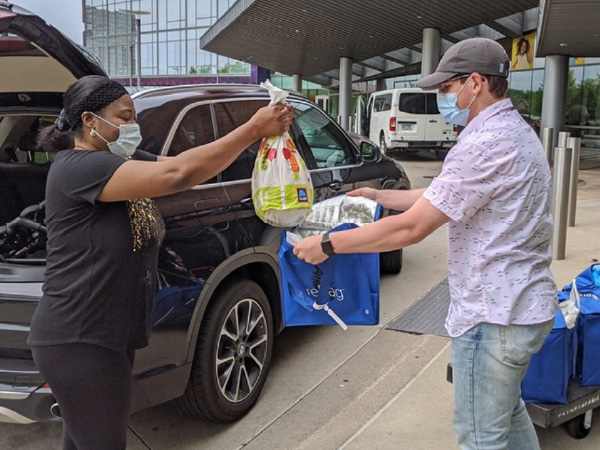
[214,100,269,181]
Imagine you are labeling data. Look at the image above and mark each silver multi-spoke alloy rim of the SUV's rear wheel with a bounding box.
[215,298,270,403]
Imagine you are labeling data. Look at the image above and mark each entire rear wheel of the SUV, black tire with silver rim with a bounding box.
[176,278,274,422]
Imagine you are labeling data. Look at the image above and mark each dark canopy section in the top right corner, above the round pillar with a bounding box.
[537,0,600,57]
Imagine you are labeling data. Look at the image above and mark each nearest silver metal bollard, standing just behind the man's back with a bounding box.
[552,147,573,260]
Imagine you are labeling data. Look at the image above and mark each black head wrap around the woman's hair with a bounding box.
[55,78,127,131]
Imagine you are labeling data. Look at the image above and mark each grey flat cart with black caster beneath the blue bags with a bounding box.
[446,364,600,439]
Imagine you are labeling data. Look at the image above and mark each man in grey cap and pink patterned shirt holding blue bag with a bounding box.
[294,38,557,450]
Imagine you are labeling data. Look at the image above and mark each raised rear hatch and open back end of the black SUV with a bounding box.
[0,2,106,384]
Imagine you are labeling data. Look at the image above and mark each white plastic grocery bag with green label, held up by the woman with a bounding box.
[252,81,313,227]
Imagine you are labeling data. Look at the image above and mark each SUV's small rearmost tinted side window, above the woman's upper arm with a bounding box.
[168,105,215,156]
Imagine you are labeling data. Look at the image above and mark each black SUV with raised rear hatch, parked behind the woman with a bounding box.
[0,3,410,423]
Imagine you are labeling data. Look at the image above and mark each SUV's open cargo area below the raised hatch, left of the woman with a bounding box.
[0,113,52,372]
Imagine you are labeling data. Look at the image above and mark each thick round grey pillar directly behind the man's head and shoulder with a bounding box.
[540,55,569,148]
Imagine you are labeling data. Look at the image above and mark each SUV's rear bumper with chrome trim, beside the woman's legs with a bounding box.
[0,384,60,424]
